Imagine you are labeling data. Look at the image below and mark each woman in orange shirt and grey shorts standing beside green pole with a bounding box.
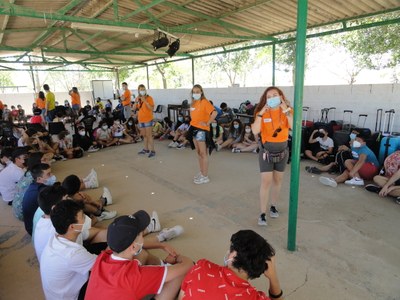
[251,86,293,226]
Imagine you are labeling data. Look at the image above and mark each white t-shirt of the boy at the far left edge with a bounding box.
[0,163,24,202]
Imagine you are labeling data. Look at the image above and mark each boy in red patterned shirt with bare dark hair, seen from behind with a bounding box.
[178,230,283,300]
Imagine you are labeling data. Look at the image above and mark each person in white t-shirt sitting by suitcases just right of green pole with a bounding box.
[304,128,334,163]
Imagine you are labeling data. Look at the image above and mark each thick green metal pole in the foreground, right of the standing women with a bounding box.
[287,0,308,251]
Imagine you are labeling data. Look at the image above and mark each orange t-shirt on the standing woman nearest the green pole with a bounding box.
[257,108,289,143]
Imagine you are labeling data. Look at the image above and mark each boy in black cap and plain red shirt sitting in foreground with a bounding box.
[85,210,193,300]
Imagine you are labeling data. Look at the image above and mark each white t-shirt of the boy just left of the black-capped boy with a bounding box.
[40,235,97,300]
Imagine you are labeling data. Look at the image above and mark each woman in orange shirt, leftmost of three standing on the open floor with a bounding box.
[134,84,156,157]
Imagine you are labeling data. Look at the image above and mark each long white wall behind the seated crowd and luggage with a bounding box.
[0,84,400,132]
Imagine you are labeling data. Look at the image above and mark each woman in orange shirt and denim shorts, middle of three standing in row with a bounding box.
[189,84,217,184]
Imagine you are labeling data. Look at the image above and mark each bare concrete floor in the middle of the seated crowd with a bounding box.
[0,141,400,300]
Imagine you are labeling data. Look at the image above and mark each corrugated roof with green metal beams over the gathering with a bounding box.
[0,0,400,70]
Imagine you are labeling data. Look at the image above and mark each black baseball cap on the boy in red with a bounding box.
[107,210,150,253]
